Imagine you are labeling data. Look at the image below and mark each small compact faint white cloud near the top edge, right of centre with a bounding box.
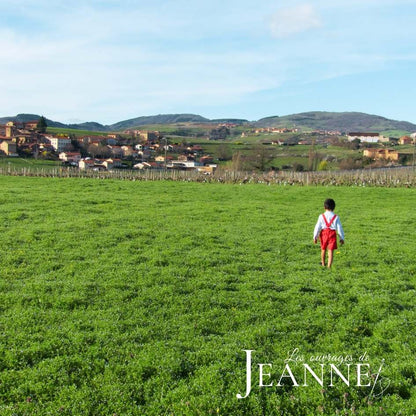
[270,4,322,38]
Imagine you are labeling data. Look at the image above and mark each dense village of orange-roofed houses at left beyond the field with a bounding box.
[0,120,217,174]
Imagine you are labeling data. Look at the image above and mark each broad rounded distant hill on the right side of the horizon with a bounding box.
[255,111,416,133]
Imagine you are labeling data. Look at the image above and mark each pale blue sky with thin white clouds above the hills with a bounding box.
[0,0,416,124]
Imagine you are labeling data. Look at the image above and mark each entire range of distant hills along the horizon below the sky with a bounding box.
[0,111,416,133]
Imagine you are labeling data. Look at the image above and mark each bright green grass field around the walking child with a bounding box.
[0,176,416,416]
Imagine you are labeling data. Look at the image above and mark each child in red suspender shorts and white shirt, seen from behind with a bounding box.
[313,199,344,267]
